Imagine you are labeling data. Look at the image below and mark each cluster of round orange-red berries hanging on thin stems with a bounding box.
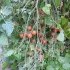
[20,10,61,55]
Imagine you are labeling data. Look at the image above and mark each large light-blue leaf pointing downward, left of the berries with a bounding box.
[2,20,14,36]
